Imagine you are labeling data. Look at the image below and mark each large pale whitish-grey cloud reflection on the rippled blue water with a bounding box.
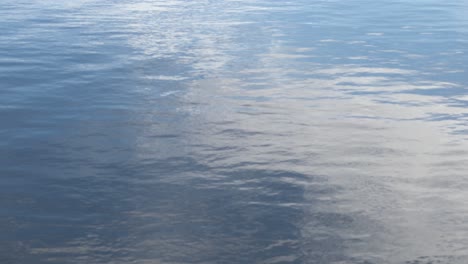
[118,2,467,262]
